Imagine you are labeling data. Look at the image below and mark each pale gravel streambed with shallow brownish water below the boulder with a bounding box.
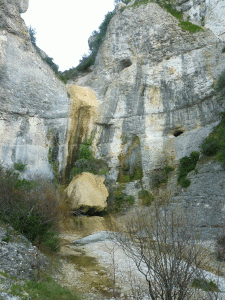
[56,217,225,300]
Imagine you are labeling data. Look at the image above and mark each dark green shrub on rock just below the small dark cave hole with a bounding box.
[178,151,199,188]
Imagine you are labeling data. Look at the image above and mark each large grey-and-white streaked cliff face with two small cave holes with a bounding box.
[74,3,225,186]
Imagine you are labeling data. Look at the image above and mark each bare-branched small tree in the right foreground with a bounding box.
[115,207,216,300]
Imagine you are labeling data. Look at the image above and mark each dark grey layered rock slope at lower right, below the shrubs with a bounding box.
[163,158,225,239]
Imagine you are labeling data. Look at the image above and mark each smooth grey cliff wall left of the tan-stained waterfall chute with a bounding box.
[0,0,70,178]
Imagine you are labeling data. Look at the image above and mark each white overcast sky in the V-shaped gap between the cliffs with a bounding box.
[21,0,114,71]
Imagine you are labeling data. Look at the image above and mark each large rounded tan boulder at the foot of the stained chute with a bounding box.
[66,172,109,212]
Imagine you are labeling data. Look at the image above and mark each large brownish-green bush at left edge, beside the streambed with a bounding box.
[0,168,67,252]
